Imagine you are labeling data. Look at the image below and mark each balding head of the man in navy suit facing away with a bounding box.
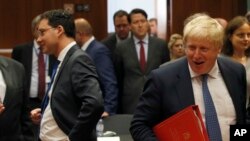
[75,18,93,36]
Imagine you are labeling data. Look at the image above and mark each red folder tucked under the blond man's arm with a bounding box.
[153,105,209,141]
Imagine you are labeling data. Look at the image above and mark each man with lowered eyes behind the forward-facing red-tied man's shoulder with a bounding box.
[102,10,131,57]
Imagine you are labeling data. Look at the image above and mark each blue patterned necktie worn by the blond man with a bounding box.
[202,74,222,141]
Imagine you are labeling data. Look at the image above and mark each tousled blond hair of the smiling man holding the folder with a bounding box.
[183,15,224,48]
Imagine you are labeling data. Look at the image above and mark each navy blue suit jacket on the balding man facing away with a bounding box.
[86,40,118,115]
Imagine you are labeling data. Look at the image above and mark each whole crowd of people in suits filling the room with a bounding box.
[0,8,250,141]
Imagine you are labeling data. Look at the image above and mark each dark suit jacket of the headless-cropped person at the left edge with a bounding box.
[0,57,34,141]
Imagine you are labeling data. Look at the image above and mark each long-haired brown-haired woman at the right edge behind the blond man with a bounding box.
[222,16,250,108]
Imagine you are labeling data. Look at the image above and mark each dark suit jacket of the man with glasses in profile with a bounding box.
[50,46,103,141]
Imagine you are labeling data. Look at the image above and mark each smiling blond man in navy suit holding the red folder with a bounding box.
[130,15,246,141]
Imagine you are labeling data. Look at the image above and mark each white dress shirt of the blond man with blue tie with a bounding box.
[189,62,236,141]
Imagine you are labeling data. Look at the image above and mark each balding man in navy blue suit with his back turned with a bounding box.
[75,18,118,117]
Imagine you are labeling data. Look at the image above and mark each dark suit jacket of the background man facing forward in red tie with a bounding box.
[114,37,170,114]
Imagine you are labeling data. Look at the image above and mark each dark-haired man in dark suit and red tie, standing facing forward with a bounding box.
[114,9,170,114]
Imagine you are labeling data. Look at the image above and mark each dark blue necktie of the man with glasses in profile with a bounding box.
[41,60,60,114]
